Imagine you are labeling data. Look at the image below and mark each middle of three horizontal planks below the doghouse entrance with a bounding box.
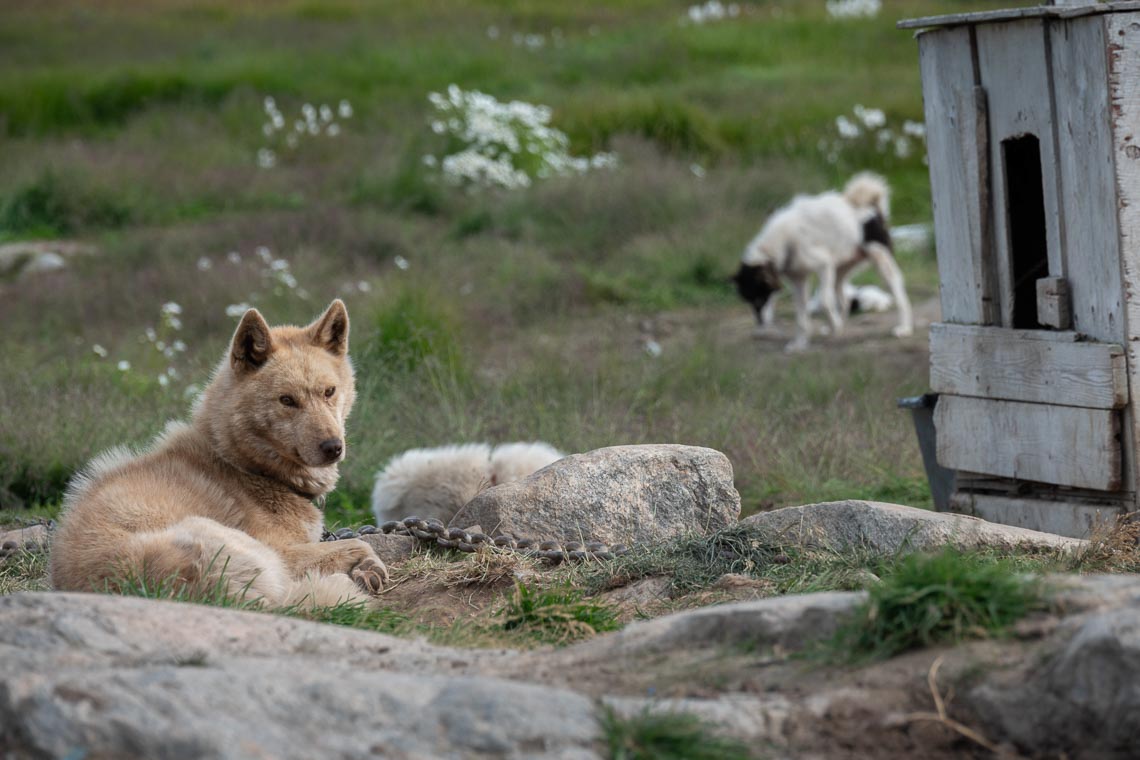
[934,395,1123,491]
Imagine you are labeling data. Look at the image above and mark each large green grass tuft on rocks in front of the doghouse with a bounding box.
[829,549,1044,662]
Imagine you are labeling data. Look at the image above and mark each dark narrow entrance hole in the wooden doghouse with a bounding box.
[1001,134,1049,329]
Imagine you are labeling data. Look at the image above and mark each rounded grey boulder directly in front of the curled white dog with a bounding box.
[451,444,740,545]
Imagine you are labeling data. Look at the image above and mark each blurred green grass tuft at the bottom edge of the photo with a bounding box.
[602,708,755,760]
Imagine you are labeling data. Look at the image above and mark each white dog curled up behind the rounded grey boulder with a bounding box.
[372,441,565,524]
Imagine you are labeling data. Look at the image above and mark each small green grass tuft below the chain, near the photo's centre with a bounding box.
[496,582,621,644]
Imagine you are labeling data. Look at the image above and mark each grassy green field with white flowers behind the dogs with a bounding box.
[0,0,1010,524]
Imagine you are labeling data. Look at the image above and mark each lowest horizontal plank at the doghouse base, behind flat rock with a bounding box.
[950,492,1124,538]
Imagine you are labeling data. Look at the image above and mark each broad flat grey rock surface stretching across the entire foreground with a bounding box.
[0,575,1140,760]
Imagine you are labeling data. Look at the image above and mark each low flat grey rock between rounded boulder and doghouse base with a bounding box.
[741,500,1085,554]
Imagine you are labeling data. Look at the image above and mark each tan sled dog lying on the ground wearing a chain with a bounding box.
[51,300,388,606]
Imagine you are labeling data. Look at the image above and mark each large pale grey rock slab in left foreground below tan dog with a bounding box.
[0,594,597,759]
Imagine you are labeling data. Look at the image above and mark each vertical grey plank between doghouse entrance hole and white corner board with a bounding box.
[1049,16,1124,343]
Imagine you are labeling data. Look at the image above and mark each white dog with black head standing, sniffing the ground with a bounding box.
[733,172,914,351]
